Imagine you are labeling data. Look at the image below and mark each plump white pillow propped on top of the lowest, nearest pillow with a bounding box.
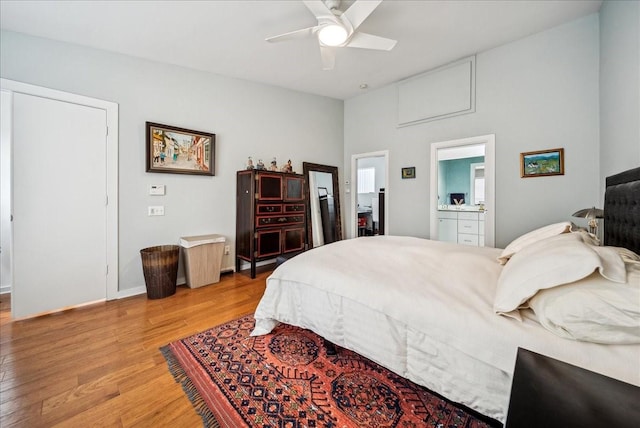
[493,233,626,318]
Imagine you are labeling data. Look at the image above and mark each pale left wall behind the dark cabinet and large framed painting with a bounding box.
[0,32,343,295]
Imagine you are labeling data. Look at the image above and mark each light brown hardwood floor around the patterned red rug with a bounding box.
[0,270,270,428]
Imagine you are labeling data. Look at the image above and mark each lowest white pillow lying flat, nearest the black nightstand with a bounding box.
[529,268,640,344]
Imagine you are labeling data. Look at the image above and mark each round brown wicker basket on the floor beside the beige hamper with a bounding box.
[140,245,180,299]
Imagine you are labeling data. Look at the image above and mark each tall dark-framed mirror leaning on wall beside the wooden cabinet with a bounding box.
[302,162,342,248]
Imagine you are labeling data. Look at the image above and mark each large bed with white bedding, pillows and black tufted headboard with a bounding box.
[252,168,640,422]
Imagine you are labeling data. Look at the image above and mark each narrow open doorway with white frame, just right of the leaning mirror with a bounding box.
[349,150,389,237]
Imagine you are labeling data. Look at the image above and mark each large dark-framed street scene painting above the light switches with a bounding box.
[146,122,216,175]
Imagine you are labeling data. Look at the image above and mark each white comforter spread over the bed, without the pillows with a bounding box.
[253,236,640,421]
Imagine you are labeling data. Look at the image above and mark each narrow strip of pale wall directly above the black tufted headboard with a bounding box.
[600,0,640,191]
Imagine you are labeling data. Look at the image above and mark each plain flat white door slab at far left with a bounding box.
[12,93,107,318]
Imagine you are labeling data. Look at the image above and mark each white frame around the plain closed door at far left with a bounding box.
[0,78,119,306]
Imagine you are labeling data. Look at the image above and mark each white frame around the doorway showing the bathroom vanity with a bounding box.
[429,134,496,247]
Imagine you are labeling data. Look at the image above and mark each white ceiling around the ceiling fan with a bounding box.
[0,0,602,99]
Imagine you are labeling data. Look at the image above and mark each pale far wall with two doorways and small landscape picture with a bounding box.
[344,14,600,247]
